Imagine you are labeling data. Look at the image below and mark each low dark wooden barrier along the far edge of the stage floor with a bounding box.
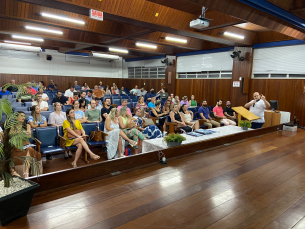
[30,125,282,196]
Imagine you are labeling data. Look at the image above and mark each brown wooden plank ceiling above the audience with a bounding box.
[0,0,305,59]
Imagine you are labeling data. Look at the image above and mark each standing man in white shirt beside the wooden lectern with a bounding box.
[245,92,270,129]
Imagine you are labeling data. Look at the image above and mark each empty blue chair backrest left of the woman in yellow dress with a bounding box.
[36,126,57,147]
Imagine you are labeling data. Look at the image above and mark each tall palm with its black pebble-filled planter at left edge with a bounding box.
[0,84,39,226]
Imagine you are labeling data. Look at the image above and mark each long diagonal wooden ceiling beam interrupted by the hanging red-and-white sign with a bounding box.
[17,0,247,46]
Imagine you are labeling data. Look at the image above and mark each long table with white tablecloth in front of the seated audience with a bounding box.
[142,126,253,153]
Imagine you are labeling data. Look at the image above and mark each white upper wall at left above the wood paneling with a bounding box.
[0,50,123,78]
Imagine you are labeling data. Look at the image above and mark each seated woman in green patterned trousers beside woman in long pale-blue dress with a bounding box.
[118,107,146,154]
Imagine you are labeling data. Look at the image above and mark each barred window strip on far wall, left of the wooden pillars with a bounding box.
[128,67,165,79]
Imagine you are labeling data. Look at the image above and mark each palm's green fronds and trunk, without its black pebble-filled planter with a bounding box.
[0,84,39,187]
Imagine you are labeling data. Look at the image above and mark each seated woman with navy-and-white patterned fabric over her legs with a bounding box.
[133,107,163,139]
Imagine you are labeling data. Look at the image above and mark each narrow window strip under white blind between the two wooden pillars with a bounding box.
[178,71,232,79]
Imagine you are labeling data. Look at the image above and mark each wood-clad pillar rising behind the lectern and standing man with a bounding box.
[230,47,253,106]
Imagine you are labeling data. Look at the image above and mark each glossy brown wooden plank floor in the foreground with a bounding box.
[6,130,305,229]
